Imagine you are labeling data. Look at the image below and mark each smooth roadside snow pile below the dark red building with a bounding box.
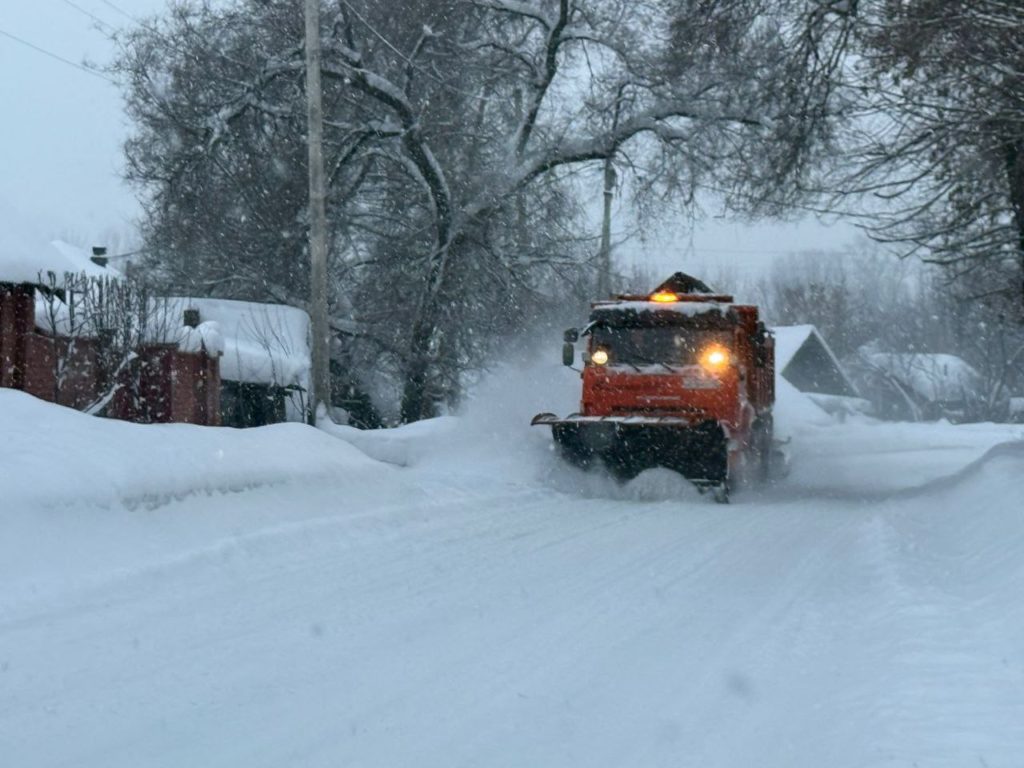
[0,389,386,512]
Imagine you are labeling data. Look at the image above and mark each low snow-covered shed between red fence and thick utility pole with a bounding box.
[169,297,311,427]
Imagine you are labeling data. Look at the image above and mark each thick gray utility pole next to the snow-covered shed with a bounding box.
[306,0,331,425]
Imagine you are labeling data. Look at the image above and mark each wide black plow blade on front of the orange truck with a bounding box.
[530,414,729,486]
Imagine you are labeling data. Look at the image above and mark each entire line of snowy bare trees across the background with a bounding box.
[114,0,1024,422]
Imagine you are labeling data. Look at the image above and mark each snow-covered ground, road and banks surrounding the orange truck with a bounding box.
[0,366,1024,768]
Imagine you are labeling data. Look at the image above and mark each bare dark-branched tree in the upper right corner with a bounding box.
[839,0,1024,309]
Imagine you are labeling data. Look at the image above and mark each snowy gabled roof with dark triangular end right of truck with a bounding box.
[771,326,859,397]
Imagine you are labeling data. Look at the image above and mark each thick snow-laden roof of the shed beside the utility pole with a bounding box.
[170,298,310,386]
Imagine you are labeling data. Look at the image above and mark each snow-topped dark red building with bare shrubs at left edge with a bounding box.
[0,238,220,424]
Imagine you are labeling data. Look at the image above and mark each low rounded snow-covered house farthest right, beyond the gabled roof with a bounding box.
[851,350,983,422]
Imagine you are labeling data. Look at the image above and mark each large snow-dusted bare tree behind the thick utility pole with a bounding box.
[119,0,849,421]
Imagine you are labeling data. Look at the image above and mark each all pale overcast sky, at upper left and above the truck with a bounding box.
[0,0,856,269]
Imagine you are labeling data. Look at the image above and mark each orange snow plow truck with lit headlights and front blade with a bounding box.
[531,272,778,502]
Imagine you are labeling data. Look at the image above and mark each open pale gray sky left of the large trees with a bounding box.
[0,0,164,247]
